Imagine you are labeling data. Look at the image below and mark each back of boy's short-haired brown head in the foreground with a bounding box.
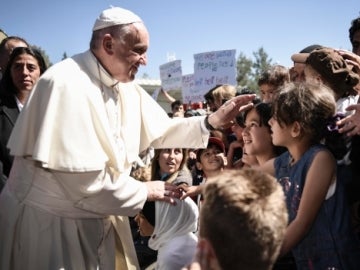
[199,169,288,269]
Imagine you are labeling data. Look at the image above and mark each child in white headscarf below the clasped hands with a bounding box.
[135,198,199,270]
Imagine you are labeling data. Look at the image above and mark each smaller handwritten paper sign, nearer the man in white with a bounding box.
[160,60,182,91]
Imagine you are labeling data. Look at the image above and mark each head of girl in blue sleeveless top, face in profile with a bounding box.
[269,83,336,147]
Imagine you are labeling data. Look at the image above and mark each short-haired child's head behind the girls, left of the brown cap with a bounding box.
[258,65,290,102]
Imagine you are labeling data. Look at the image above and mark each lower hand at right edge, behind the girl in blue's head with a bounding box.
[336,104,360,136]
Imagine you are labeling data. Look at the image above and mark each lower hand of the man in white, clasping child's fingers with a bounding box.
[144,181,182,204]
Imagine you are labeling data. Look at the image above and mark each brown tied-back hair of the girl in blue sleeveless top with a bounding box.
[273,82,347,159]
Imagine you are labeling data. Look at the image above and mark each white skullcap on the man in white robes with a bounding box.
[93,7,142,31]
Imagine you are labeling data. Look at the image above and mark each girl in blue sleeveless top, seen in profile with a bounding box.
[263,83,360,269]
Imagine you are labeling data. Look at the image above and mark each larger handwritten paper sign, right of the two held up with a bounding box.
[194,50,236,95]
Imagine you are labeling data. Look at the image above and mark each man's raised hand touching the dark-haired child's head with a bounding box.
[208,95,256,129]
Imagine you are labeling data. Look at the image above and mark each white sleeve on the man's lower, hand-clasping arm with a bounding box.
[54,169,147,216]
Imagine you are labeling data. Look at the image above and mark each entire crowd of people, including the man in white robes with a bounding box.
[0,7,360,270]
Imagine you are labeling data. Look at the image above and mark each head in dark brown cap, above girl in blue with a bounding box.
[304,48,360,99]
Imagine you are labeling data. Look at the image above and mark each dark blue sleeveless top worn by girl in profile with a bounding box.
[274,144,360,270]
